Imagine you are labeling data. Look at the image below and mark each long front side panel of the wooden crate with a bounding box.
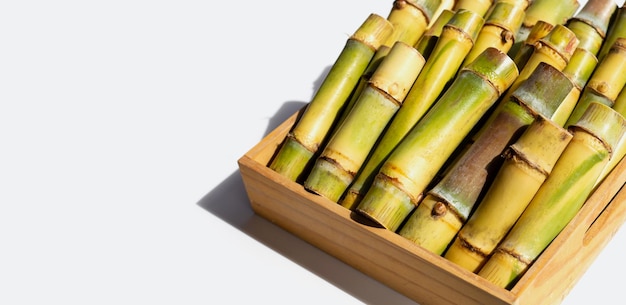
[240,157,514,305]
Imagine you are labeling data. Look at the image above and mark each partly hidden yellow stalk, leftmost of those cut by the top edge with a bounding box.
[383,0,441,47]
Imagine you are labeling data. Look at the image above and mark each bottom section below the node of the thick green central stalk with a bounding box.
[356,174,415,232]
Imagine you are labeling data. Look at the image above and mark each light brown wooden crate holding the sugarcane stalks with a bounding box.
[238,108,626,305]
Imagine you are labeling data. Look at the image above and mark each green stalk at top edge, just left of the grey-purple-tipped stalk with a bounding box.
[509,0,580,58]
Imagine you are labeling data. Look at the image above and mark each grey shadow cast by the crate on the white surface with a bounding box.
[197,102,415,305]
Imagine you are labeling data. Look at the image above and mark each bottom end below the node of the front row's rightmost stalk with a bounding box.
[478,249,530,290]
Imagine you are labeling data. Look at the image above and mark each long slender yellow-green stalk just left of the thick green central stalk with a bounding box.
[341,10,484,208]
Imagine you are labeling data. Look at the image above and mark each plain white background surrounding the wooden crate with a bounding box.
[0,0,626,305]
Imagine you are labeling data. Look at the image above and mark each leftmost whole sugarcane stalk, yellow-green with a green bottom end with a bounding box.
[269,14,393,182]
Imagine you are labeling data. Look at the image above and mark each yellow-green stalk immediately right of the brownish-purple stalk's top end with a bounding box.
[552,48,598,126]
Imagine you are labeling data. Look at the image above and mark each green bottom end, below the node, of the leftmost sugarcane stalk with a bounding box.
[269,134,314,182]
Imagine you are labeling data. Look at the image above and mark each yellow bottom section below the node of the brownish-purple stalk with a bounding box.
[398,195,463,255]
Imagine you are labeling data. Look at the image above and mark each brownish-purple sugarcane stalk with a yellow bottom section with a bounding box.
[399,63,573,254]
